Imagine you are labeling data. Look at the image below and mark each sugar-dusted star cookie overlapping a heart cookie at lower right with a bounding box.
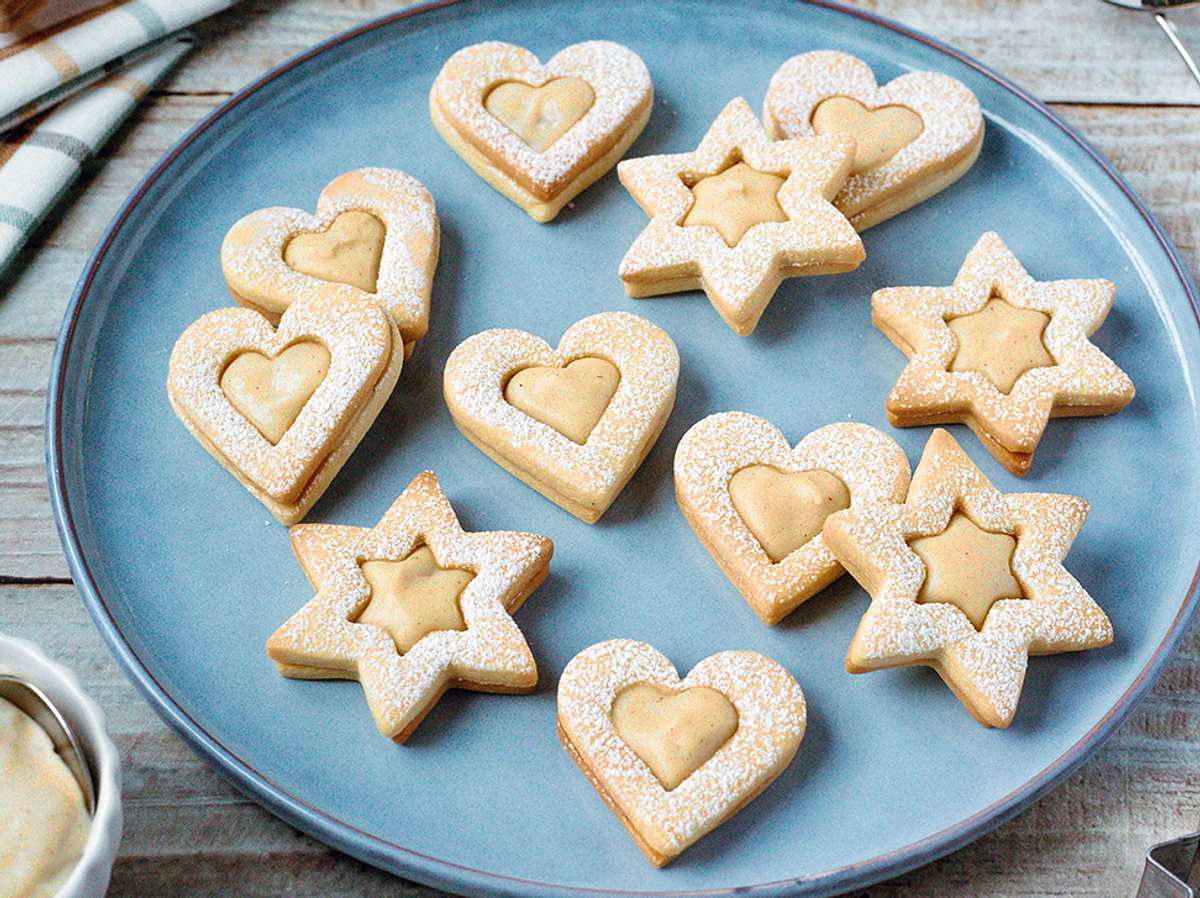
[822,429,1112,728]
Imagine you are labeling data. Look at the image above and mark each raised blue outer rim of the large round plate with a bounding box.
[44,0,1200,898]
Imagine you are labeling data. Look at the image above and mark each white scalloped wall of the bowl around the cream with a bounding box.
[0,633,122,898]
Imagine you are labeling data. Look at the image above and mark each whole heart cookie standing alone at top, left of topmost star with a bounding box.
[430,41,654,221]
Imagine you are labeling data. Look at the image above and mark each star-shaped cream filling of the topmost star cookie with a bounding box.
[683,162,787,246]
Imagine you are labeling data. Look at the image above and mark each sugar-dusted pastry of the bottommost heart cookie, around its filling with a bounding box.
[558,640,806,856]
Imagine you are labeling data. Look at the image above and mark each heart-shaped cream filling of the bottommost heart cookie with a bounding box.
[612,683,738,792]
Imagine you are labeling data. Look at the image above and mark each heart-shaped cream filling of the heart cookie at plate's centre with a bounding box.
[504,357,620,445]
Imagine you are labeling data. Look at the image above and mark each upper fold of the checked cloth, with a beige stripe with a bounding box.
[0,0,234,131]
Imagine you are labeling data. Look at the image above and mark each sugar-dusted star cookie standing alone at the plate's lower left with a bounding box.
[266,471,553,742]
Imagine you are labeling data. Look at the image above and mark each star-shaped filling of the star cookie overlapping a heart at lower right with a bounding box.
[908,513,1024,630]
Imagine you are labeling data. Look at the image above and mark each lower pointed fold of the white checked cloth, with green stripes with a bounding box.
[0,35,192,270]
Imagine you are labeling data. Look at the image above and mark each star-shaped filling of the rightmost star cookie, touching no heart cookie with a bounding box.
[948,295,1054,394]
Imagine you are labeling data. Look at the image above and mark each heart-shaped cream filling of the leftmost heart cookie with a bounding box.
[221,340,329,445]
